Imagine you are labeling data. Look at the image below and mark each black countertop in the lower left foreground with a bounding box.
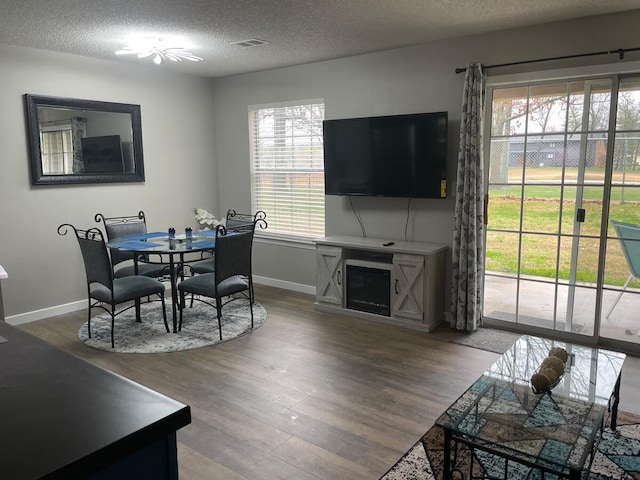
[0,322,191,480]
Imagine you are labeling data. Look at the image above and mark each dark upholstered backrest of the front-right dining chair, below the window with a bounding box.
[214,225,253,285]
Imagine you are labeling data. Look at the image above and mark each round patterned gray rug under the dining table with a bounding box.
[78,299,267,353]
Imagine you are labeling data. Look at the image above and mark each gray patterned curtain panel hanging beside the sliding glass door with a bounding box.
[449,63,484,331]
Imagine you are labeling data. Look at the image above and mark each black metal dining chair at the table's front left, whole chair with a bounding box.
[58,223,169,348]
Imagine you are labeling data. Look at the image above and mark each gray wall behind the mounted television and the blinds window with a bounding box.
[215,11,640,291]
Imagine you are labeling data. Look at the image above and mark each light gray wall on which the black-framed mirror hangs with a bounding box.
[0,47,217,323]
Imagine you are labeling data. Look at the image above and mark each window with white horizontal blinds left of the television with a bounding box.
[249,100,324,238]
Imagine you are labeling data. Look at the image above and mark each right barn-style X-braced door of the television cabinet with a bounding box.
[391,253,424,322]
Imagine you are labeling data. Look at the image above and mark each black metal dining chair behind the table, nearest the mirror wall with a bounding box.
[95,210,169,278]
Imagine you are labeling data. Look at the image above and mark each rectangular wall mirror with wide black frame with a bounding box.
[25,94,144,185]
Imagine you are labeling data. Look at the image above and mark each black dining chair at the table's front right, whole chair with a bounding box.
[178,225,253,340]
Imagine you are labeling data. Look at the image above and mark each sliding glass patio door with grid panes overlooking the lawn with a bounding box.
[483,72,640,343]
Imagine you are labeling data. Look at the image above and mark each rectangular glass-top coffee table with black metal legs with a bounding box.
[436,335,626,480]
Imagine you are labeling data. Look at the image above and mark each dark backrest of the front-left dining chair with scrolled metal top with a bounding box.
[58,223,113,290]
